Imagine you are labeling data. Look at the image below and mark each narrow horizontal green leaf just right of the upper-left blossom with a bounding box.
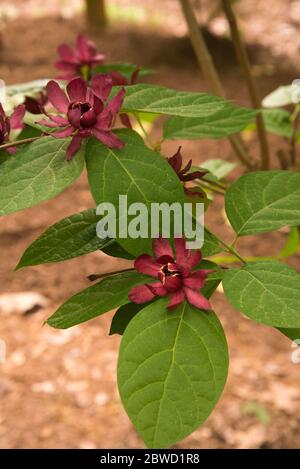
[120,84,227,117]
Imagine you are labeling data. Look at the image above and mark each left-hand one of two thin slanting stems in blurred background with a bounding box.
[180,0,252,169]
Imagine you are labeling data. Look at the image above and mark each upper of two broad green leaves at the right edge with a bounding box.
[225,171,300,236]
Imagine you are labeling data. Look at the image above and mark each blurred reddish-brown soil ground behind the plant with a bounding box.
[0,2,300,448]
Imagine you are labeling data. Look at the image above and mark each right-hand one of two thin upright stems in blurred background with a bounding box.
[222,0,270,169]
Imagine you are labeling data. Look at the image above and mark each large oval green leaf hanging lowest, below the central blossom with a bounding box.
[118,300,228,448]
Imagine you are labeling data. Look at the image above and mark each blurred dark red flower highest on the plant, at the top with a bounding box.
[54,34,105,80]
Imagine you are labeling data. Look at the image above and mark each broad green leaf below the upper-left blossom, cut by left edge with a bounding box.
[0,137,84,215]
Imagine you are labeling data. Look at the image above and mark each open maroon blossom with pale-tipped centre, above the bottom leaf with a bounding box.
[128,238,211,310]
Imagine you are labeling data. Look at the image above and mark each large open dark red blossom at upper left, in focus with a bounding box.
[38,74,125,160]
